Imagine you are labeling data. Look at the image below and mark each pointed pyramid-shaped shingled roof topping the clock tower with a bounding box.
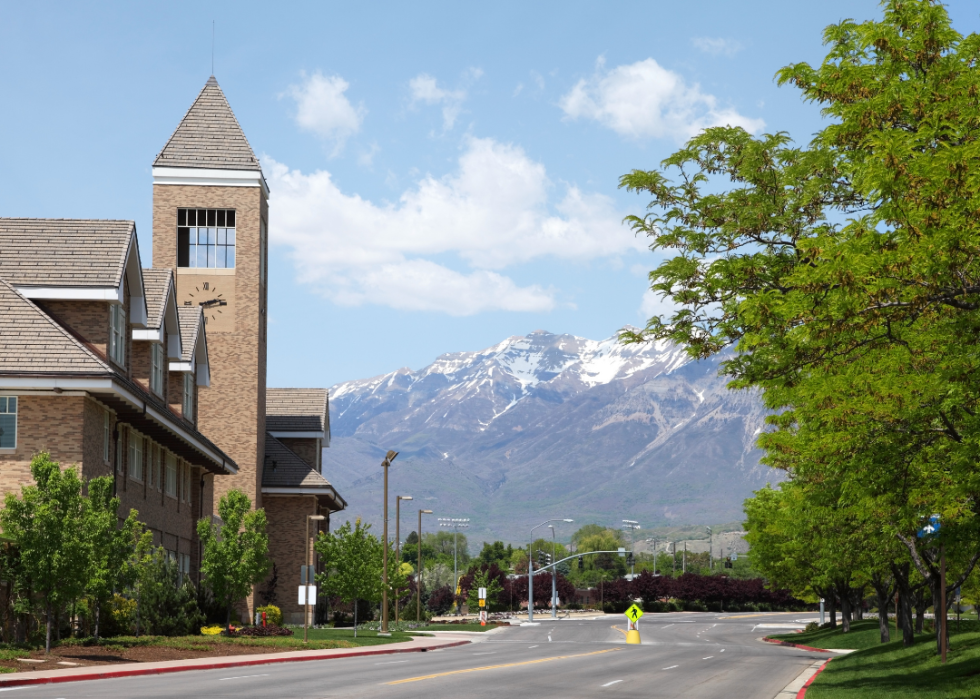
[153,75,262,172]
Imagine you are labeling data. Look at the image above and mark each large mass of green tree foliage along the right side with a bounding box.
[622,0,980,656]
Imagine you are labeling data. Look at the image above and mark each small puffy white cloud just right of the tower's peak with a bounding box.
[287,72,367,149]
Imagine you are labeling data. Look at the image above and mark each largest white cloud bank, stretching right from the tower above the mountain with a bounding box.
[263,139,645,315]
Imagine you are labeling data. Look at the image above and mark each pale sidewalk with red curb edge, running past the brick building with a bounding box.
[0,633,472,691]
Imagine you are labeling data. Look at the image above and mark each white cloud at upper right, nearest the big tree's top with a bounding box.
[559,58,765,140]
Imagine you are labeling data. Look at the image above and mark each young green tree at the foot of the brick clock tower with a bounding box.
[197,490,272,624]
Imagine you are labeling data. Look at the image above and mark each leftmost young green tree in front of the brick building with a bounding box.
[0,453,90,653]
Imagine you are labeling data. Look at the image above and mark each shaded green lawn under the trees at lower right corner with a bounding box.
[773,620,980,699]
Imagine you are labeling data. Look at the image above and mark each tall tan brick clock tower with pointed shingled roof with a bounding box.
[153,76,269,511]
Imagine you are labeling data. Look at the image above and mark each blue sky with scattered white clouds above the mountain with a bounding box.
[0,0,980,386]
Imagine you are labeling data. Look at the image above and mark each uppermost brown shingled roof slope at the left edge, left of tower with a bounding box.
[0,218,136,288]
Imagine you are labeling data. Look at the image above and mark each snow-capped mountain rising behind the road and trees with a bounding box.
[324,330,780,541]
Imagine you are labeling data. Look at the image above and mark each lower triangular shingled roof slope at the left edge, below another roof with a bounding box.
[0,279,113,375]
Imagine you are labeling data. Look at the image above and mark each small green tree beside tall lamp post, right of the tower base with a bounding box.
[313,518,384,637]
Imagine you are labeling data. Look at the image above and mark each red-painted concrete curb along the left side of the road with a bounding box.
[0,640,472,690]
